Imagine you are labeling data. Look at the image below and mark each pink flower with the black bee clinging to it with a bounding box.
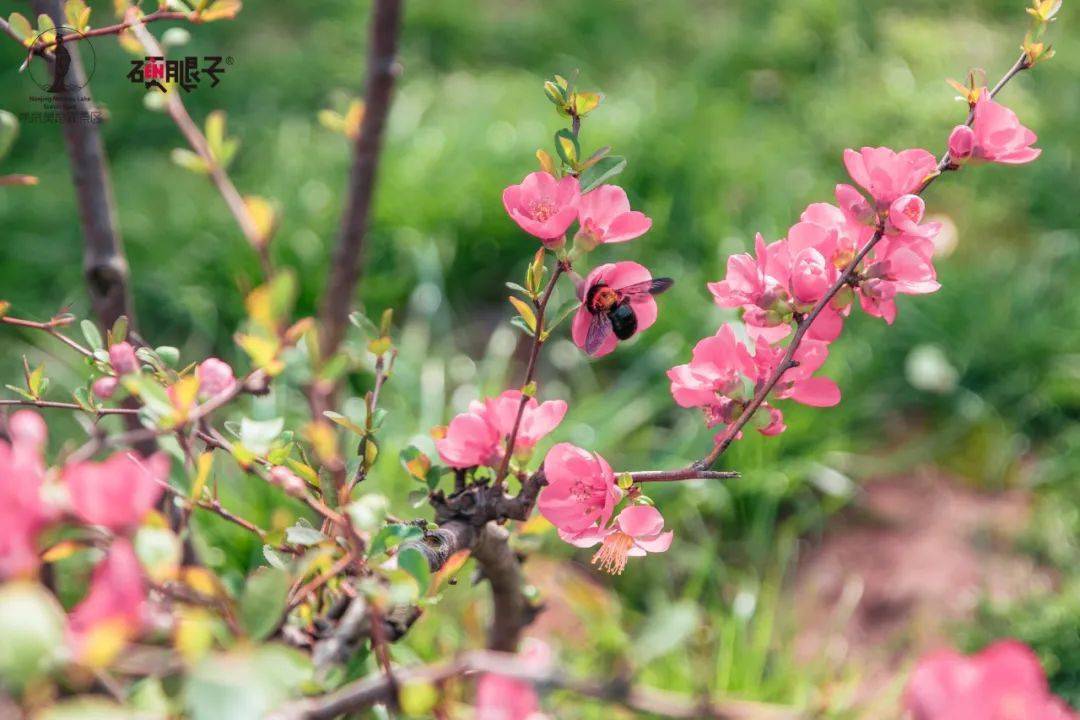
[570,260,657,357]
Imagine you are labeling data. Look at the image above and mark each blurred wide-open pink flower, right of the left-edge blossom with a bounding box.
[63,451,170,532]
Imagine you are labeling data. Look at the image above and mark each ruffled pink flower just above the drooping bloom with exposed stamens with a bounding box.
[537,443,622,544]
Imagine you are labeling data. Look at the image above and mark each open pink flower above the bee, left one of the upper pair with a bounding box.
[502,173,580,243]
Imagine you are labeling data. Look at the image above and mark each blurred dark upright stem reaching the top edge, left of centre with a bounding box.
[320,0,402,362]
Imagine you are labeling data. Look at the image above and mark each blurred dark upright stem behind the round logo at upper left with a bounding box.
[33,0,135,328]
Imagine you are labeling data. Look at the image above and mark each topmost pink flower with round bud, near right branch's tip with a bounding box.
[948,87,1042,165]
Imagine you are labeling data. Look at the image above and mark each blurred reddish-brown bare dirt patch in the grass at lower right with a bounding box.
[788,473,1053,705]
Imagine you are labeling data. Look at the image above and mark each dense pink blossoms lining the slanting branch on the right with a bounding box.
[667,89,1039,440]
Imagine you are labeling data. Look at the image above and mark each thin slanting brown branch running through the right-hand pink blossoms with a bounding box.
[687,47,1030,471]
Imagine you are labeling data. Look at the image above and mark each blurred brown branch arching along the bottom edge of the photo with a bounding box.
[269,652,800,720]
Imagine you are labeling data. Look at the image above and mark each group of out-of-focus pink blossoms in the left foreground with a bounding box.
[0,410,170,666]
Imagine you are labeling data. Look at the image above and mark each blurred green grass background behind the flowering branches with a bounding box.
[0,0,1080,718]
